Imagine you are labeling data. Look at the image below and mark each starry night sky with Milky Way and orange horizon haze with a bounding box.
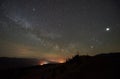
[0,0,120,60]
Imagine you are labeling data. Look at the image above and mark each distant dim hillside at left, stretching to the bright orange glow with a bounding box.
[0,57,39,70]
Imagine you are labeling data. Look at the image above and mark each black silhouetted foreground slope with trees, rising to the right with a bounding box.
[0,53,120,79]
